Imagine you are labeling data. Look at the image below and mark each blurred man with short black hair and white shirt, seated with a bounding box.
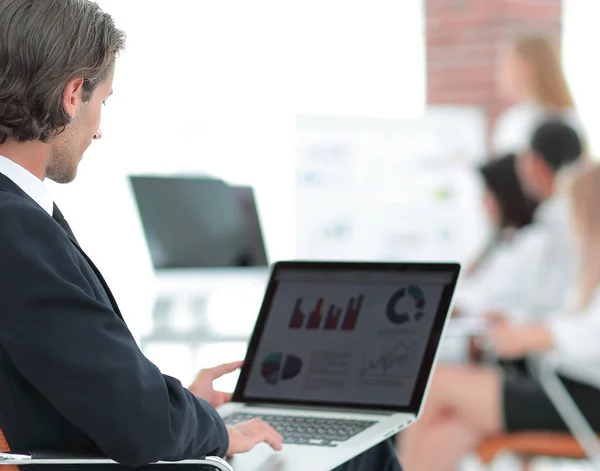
[456,120,582,321]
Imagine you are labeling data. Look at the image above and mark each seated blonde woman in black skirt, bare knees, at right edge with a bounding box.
[400,160,600,471]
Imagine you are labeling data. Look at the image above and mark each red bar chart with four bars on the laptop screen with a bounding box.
[289,294,365,332]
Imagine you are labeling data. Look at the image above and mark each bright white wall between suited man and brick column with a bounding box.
[51,0,425,335]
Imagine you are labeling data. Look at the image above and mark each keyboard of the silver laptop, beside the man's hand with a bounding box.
[224,412,377,447]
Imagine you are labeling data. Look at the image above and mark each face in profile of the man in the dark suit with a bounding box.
[46,70,114,183]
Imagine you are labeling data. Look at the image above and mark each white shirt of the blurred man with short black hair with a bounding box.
[457,190,577,323]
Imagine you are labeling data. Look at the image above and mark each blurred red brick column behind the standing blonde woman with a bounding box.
[424,0,562,148]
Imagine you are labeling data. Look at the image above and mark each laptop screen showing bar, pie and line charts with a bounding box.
[234,262,459,413]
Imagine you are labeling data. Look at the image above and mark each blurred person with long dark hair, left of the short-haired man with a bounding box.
[455,154,537,318]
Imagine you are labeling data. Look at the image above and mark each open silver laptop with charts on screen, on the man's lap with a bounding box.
[219,261,460,471]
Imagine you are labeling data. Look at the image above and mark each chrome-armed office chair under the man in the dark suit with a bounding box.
[0,429,234,471]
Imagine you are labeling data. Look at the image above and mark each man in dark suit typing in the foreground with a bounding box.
[0,0,399,471]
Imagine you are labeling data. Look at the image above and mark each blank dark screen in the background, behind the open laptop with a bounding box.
[130,175,267,269]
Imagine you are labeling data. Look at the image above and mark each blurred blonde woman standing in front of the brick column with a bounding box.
[492,35,583,154]
